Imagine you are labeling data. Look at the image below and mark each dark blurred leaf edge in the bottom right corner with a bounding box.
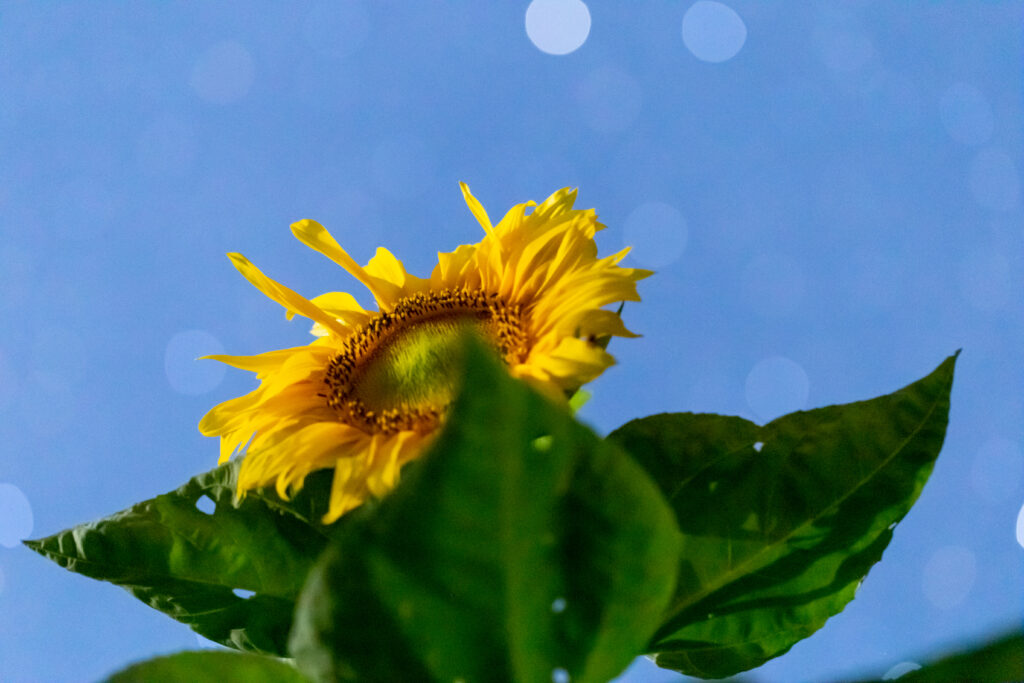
[860,631,1024,683]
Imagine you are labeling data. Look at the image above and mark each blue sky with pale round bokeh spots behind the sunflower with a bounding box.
[0,0,1024,682]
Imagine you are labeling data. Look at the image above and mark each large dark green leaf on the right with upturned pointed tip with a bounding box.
[608,355,956,678]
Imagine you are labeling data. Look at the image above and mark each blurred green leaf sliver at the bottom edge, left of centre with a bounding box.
[105,650,309,683]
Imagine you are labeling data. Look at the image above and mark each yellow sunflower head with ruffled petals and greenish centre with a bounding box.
[199,183,650,523]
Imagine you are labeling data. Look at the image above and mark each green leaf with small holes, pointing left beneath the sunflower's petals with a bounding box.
[26,462,328,654]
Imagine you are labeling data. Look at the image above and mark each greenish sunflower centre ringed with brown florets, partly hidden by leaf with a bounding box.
[327,290,526,433]
